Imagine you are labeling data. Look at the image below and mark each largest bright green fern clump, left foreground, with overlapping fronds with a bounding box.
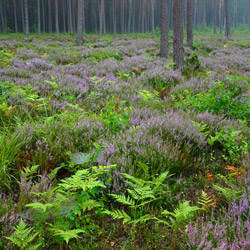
[26,165,114,244]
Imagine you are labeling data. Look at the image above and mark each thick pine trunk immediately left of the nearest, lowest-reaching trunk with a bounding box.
[160,0,169,57]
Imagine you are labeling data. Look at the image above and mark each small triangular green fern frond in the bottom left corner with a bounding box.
[5,219,41,250]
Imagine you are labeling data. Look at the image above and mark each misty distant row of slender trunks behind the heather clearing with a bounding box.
[0,0,250,36]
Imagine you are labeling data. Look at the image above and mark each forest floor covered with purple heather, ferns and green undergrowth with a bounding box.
[0,31,250,250]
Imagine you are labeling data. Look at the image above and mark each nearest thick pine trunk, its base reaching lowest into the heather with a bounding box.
[173,0,184,69]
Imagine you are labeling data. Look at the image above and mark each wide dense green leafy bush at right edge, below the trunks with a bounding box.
[176,76,250,121]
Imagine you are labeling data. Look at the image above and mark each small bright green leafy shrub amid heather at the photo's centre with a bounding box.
[100,97,131,133]
